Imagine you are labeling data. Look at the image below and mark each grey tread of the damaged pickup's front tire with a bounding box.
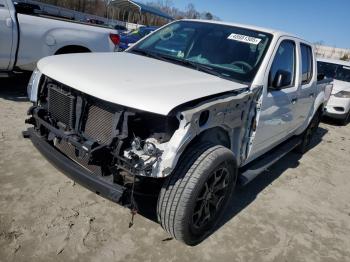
[157,143,232,242]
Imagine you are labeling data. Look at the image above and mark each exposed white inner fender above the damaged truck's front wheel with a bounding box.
[152,88,262,177]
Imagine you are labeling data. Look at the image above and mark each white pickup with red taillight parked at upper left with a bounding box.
[0,0,119,75]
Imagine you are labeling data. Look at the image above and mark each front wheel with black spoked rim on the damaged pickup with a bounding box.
[157,144,237,245]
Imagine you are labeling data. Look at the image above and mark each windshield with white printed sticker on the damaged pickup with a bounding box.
[130,21,272,83]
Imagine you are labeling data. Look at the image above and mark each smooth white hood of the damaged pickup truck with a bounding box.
[38,53,246,115]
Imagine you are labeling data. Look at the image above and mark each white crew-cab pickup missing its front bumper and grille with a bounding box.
[24,20,332,245]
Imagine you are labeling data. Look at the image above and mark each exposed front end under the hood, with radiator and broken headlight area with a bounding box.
[27,77,179,184]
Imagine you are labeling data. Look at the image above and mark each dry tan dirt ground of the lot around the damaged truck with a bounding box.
[0,76,350,262]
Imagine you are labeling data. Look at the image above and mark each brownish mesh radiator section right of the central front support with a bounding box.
[84,104,114,144]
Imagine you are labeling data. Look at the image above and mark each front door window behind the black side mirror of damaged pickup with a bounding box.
[269,40,296,89]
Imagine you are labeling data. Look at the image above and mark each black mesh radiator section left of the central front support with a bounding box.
[48,84,75,129]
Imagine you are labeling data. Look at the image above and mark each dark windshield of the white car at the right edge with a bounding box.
[317,62,350,82]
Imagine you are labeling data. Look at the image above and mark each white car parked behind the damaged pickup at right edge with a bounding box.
[317,58,350,125]
